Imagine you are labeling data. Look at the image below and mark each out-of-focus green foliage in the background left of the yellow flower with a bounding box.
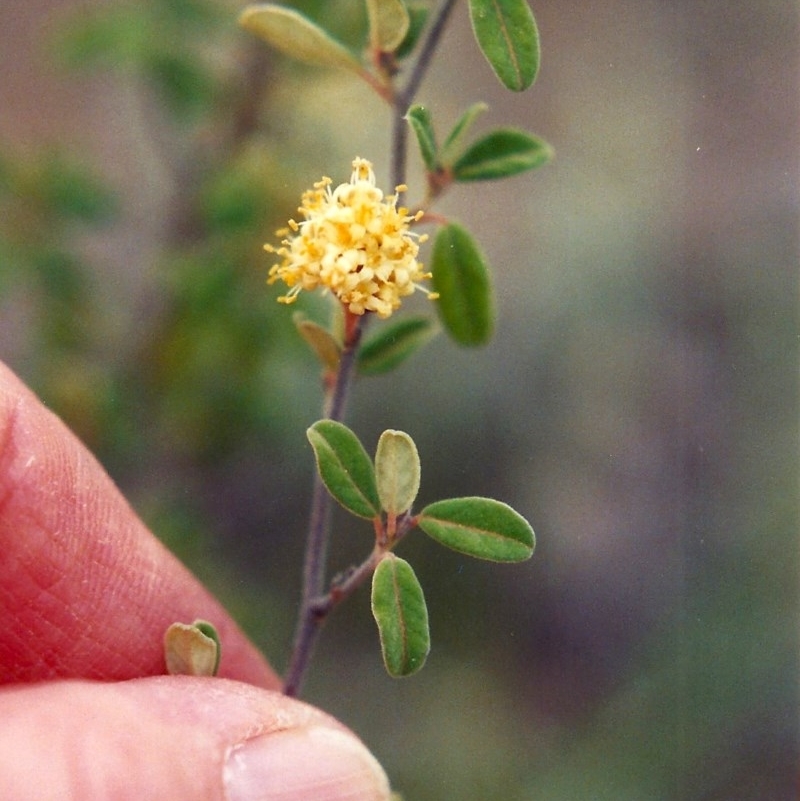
[0,0,356,472]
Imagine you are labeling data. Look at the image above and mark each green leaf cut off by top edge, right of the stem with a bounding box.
[469,0,539,92]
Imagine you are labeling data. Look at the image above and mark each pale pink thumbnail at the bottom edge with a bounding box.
[223,726,390,801]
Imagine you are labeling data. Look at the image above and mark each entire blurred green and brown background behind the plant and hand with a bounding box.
[0,0,800,801]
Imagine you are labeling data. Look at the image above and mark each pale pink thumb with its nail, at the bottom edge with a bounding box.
[0,676,390,801]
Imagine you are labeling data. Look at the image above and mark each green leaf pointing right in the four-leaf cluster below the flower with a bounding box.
[417,497,536,562]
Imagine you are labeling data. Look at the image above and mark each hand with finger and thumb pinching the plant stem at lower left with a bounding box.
[0,364,389,801]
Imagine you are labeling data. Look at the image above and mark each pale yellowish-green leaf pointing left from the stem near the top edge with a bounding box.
[239,3,361,72]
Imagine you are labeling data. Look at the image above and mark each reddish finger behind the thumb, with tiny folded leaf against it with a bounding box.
[0,363,280,688]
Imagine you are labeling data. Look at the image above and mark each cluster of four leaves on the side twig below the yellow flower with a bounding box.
[307,420,535,676]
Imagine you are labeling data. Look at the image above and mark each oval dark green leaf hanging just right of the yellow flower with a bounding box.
[431,223,494,346]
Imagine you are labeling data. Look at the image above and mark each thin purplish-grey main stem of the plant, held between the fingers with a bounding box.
[283,0,456,696]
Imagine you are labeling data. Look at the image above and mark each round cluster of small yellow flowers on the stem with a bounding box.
[264,158,436,318]
